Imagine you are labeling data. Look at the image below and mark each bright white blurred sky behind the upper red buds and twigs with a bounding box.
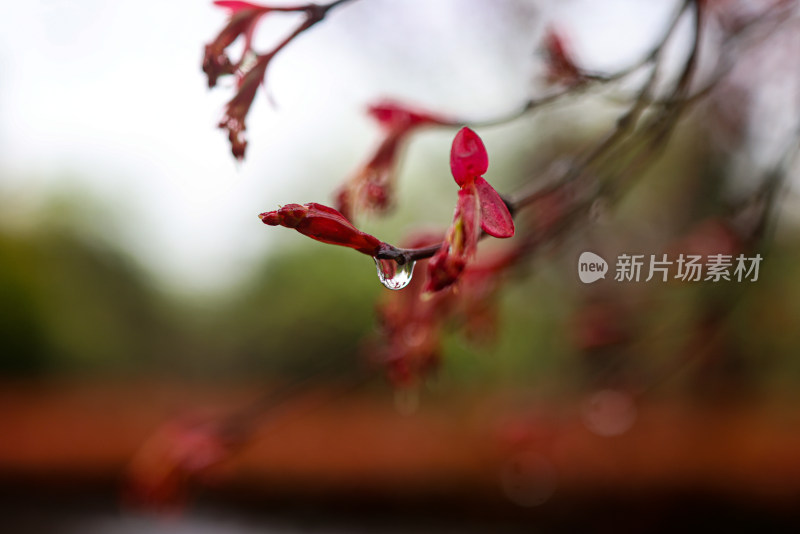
[0,0,688,296]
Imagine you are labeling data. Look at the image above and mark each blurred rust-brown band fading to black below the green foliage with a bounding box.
[0,382,800,532]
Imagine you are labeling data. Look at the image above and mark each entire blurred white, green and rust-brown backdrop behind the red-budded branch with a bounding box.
[0,0,800,532]
